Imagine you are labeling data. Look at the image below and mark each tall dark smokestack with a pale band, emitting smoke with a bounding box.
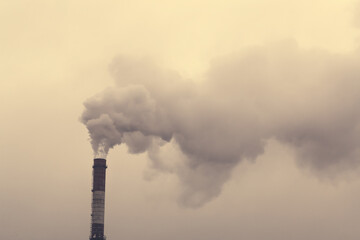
[90,158,107,240]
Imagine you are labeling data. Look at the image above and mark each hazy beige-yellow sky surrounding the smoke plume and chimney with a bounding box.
[0,0,360,240]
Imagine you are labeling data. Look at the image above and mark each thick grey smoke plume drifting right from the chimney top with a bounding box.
[81,42,360,207]
